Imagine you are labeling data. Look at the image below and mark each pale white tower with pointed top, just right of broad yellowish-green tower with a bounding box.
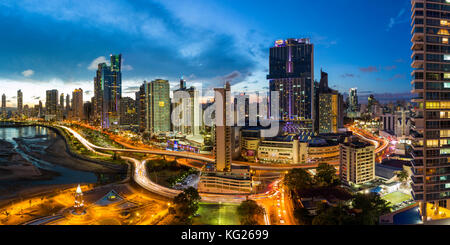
[172,78,202,135]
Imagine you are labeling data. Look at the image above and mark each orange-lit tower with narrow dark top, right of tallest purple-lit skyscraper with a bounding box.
[315,71,344,133]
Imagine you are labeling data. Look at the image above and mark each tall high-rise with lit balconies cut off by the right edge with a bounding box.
[411,0,450,218]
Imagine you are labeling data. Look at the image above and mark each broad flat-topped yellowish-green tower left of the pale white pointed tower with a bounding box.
[139,79,171,133]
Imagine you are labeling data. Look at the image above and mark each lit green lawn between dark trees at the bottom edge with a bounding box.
[193,203,240,225]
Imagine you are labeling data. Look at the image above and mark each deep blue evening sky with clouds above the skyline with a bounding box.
[0,0,411,106]
